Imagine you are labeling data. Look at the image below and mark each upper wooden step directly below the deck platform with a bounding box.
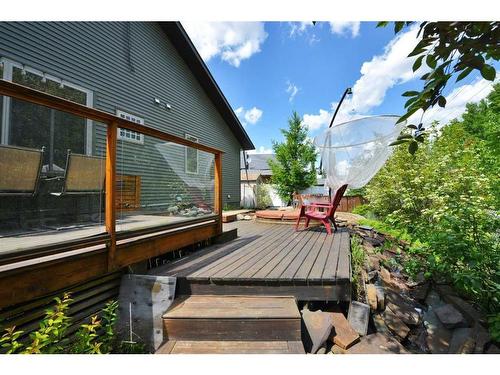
[163,295,301,341]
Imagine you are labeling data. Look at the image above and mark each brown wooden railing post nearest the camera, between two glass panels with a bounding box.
[105,122,118,271]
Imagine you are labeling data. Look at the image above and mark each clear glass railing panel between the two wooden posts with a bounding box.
[116,129,214,231]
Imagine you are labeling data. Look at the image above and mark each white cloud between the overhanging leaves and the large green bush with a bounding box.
[408,76,499,126]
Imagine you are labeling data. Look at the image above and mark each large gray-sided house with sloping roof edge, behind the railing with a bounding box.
[0,22,254,214]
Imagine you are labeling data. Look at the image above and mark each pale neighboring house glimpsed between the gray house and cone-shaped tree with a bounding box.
[240,153,285,208]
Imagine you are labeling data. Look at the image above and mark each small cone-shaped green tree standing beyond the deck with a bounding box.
[269,112,317,204]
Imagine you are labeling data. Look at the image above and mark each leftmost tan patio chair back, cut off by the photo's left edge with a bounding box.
[0,145,44,196]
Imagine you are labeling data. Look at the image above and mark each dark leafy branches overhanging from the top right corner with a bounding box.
[377,21,500,153]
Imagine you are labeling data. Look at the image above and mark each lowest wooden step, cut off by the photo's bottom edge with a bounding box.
[155,341,305,354]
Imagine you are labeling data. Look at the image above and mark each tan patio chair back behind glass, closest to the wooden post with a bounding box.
[51,150,106,196]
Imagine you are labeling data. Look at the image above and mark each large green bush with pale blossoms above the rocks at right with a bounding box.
[363,85,500,312]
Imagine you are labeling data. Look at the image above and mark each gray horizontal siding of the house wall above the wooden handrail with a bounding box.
[0,22,241,205]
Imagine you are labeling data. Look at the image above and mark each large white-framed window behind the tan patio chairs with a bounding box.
[2,60,92,172]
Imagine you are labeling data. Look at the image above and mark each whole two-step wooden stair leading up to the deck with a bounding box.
[157,295,304,354]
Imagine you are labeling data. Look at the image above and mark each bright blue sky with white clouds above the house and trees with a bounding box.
[183,22,491,152]
